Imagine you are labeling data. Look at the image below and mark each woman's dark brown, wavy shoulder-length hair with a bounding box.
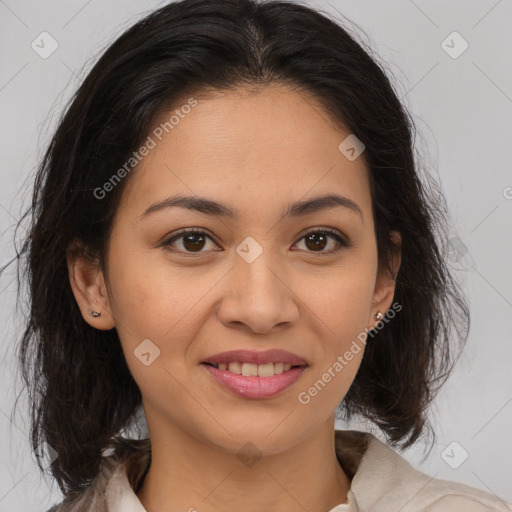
[4,0,469,495]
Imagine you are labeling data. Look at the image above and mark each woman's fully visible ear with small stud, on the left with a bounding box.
[66,240,115,330]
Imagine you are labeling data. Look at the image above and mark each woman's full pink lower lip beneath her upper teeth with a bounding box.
[202,363,307,398]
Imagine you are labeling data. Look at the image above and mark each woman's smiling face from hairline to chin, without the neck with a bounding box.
[74,85,400,453]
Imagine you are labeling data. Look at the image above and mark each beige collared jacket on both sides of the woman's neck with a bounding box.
[47,430,512,512]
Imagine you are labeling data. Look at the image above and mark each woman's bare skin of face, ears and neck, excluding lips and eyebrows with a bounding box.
[68,84,400,512]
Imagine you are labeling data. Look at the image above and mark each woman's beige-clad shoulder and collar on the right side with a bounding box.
[336,431,512,512]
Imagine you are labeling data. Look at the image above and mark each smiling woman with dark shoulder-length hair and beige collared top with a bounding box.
[6,0,512,512]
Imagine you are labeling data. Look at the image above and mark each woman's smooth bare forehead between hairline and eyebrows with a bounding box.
[117,85,371,221]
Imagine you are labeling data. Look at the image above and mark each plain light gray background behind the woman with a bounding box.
[0,0,512,512]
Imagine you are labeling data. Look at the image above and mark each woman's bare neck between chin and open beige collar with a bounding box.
[137,418,350,512]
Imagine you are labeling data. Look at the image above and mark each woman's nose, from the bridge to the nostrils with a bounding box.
[218,250,300,334]
